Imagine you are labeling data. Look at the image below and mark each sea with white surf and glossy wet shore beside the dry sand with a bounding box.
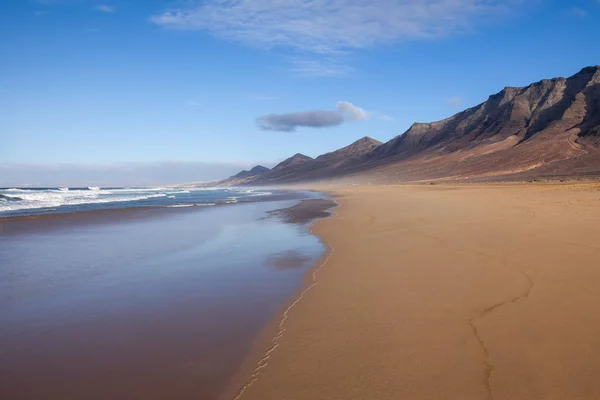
[0,188,326,400]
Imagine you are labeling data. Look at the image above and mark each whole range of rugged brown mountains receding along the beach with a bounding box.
[221,66,600,185]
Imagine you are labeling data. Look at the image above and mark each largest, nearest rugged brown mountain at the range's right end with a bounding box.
[366,67,600,180]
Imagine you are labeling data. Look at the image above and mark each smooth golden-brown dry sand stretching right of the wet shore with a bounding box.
[230,184,600,400]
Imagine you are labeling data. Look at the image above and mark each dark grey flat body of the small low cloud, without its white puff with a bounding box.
[257,110,344,132]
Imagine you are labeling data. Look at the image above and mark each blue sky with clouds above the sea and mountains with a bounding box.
[0,0,600,186]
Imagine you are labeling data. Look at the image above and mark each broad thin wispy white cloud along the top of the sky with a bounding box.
[150,0,525,55]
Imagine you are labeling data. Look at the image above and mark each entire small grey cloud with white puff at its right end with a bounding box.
[256,101,372,132]
